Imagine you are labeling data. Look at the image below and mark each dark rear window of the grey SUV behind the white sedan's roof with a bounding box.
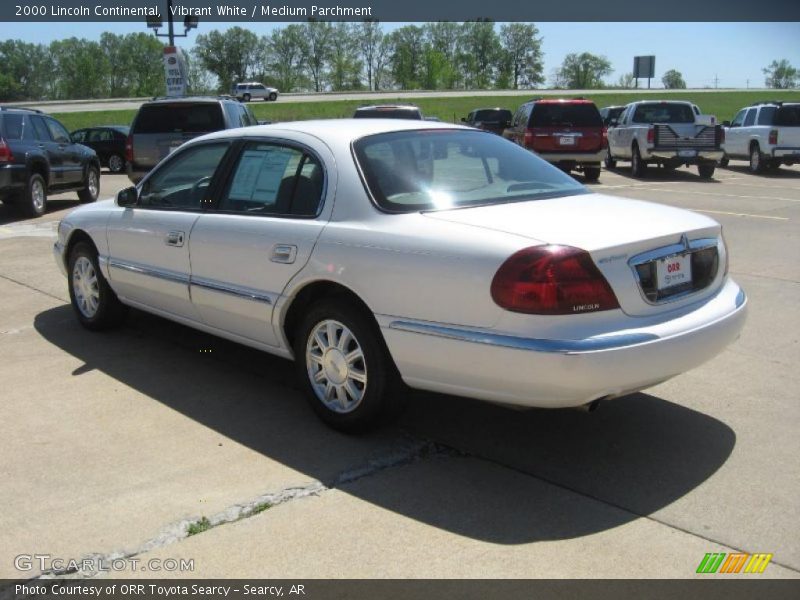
[133,103,225,133]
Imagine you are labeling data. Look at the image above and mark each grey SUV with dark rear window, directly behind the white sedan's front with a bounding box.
[125,96,258,183]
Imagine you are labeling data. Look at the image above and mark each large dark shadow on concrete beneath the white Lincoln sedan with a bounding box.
[34,305,736,544]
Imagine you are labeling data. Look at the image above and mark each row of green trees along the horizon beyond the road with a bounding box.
[0,20,797,101]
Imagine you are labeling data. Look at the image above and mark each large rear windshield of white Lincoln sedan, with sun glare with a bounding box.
[353,129,588,212]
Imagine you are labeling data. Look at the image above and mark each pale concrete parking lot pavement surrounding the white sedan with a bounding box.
[0,162,800,578]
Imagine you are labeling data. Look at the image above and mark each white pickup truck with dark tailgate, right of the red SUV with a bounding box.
[605,100,725,179]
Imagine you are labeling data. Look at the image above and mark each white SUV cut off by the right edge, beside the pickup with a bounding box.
[720,102,800,173]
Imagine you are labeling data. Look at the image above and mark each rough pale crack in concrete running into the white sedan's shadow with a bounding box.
[31,434,456,580]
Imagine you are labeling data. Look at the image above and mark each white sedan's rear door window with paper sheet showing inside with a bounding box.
[219,142,324,217]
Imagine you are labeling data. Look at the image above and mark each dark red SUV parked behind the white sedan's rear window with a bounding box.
[503,98,605,181]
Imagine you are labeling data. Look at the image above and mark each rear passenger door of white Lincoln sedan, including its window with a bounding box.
[190,139,333,346]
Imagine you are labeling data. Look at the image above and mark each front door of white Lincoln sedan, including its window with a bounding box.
[107,142,230,321]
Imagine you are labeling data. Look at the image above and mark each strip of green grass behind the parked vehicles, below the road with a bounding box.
[54,90,800,131]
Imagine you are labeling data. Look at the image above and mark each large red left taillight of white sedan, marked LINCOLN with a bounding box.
[491,246,619,315]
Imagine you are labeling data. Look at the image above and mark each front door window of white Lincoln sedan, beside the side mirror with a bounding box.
[139,142,228,210]
